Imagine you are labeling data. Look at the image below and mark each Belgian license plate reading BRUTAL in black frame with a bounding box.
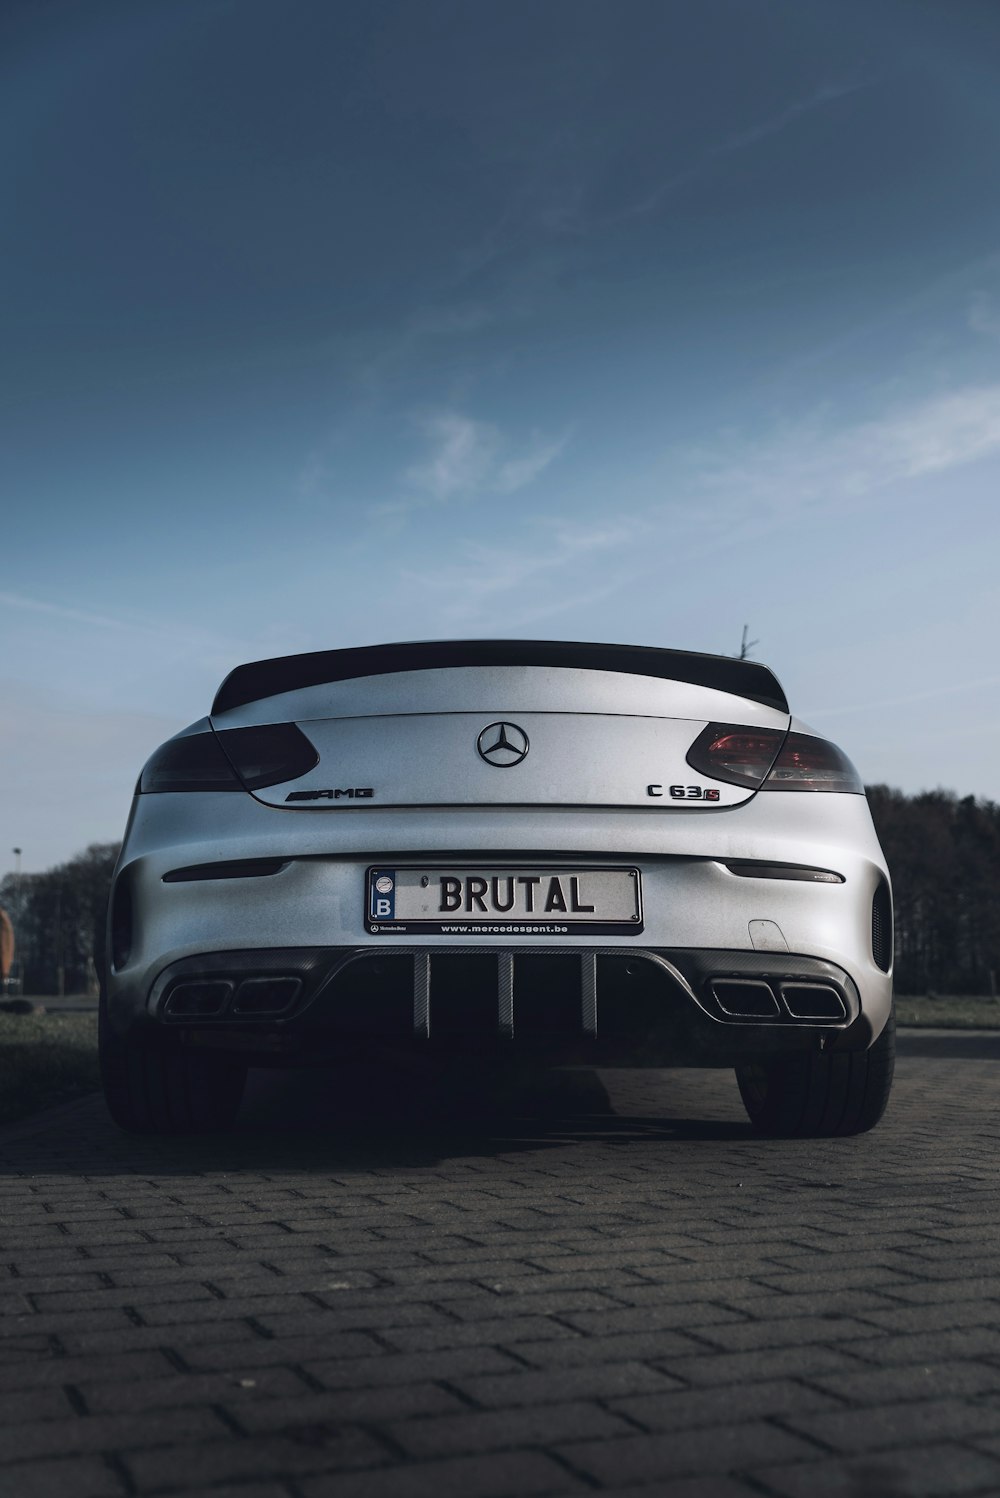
[365,864,642,936]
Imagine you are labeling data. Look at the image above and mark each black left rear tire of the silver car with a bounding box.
[99,995,247,1134]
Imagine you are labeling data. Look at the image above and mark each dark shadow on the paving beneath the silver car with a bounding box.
[0,1068,753,1176]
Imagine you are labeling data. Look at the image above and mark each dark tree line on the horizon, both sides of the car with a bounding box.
[0,785,1000,995]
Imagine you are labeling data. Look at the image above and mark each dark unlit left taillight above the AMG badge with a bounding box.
[136,724,319,792]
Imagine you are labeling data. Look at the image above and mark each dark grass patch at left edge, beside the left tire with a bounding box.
[0,1013,100,1124]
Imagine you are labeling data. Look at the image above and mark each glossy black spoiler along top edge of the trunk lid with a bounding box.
[211,640,789,713]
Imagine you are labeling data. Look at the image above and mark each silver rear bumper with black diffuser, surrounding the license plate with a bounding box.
[108,792,892,1065]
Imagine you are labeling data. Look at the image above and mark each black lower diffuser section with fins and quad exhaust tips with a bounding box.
[109,944,891,1067]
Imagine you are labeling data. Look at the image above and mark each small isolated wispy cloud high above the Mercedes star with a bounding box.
[394,410,569,508]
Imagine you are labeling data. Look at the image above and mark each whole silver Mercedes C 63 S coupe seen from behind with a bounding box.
[100,640,894,1135]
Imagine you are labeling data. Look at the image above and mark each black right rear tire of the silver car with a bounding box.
[737,1014,895,1138]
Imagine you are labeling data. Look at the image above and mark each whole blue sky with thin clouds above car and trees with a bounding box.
[0,0,1000,870]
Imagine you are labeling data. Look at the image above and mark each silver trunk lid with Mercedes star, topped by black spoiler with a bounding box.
[213,643,790,810]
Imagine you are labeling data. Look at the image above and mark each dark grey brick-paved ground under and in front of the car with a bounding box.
[0,1043,1000,1498]
